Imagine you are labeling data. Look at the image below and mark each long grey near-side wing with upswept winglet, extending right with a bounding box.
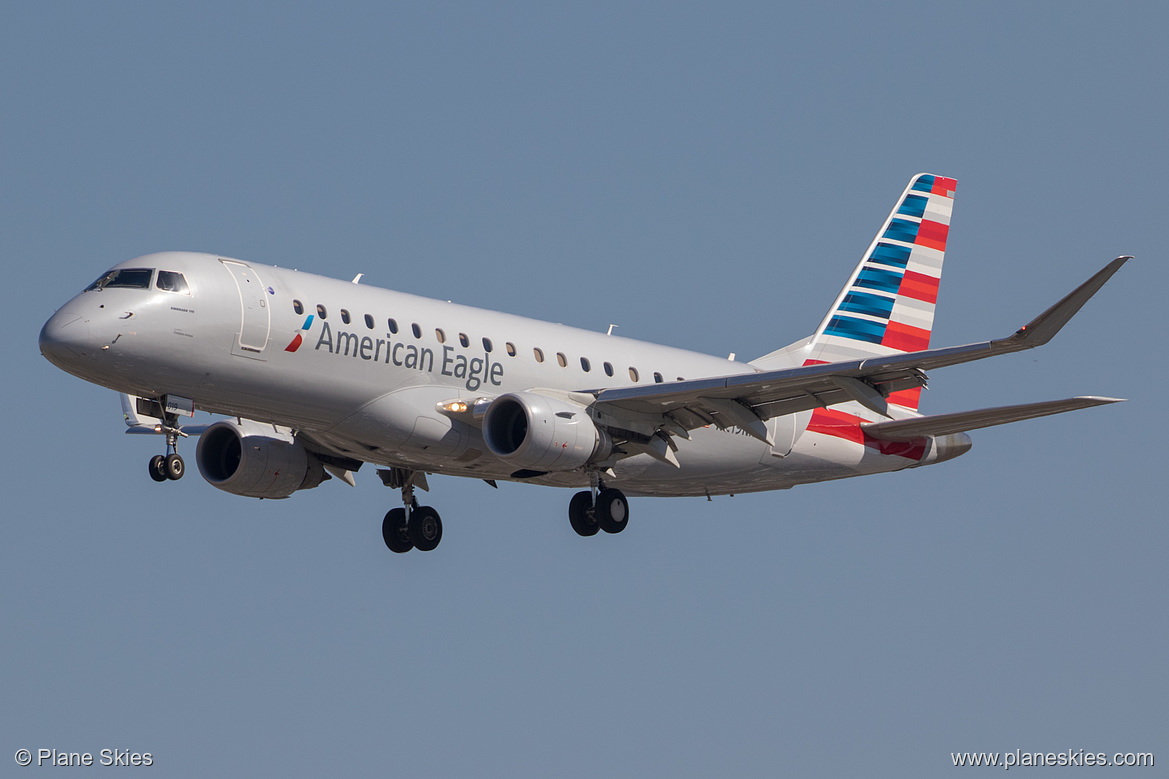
[595,256,1132,432]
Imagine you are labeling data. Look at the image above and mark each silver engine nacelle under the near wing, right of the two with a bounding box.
[483,392,613,471]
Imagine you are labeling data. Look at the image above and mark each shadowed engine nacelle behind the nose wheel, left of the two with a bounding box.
[195,421,327,498]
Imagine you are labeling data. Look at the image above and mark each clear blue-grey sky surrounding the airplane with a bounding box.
[0,1,1169,777]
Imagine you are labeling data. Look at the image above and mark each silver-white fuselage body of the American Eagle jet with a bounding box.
[41,253,949,495]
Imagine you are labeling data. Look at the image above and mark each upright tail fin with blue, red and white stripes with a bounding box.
[803,173,957,409]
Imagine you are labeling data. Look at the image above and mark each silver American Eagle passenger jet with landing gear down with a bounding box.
[40,173,1132,553]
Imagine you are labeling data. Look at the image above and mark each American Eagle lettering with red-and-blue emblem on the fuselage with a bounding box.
[284,313,504,392]
